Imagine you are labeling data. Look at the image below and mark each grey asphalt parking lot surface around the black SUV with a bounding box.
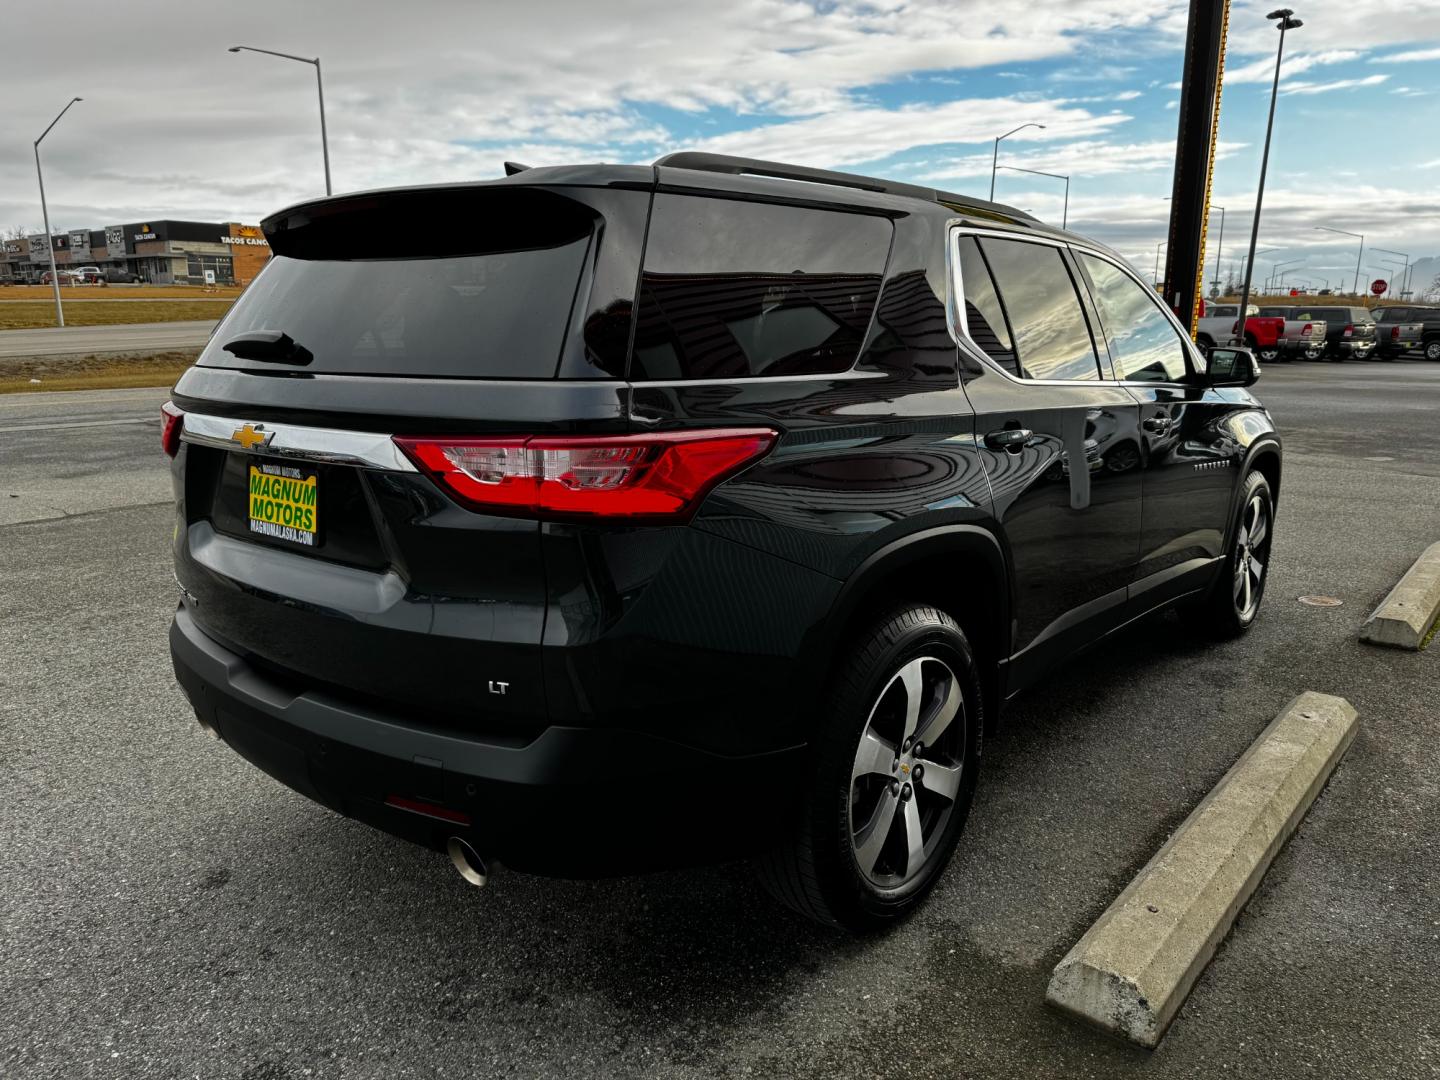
[0,361,1440,1080]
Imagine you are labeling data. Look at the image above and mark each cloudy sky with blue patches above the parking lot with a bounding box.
[0,0,1440,288]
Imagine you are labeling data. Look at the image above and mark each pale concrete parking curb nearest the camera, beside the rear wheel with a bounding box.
[1045,691,1356,1048]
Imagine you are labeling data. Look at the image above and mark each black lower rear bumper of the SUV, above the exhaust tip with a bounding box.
[170,606,804,877]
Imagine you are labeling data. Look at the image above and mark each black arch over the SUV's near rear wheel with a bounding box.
[806,524,1011,730]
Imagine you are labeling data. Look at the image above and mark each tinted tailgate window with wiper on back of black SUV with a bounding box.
[200,190,595,379]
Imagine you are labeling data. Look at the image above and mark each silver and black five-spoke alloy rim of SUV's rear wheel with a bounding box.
[850,655,968,888]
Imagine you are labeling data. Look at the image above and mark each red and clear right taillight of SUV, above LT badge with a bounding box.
[395,428,776,520]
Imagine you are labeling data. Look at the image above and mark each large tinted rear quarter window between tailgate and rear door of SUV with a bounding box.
[629,194,894,380]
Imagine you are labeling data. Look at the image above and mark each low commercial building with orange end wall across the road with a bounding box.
[0,219,269,285]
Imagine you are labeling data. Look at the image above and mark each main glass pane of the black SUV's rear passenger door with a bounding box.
[979,236,1100,382]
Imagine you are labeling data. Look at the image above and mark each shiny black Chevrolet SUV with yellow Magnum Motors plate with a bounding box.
[164,154,1280,929]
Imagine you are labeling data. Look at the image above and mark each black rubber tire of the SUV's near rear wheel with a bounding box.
[756,605,984,933]
